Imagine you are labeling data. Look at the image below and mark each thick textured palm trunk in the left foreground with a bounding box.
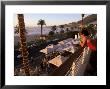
[18,14,30,76]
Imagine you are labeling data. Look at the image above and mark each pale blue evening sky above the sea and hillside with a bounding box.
[14,14,88,27]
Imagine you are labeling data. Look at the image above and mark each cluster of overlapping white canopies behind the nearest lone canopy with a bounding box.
[40,38,79,54]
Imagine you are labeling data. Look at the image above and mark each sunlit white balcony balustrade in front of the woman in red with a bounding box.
[66,47,91,76]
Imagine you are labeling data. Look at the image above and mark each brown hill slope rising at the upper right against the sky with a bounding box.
[77,14,97,24]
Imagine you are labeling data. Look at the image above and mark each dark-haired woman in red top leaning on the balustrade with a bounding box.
[80,28,97,75]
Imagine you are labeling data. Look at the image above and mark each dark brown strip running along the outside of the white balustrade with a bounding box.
[49,47,84,76]
